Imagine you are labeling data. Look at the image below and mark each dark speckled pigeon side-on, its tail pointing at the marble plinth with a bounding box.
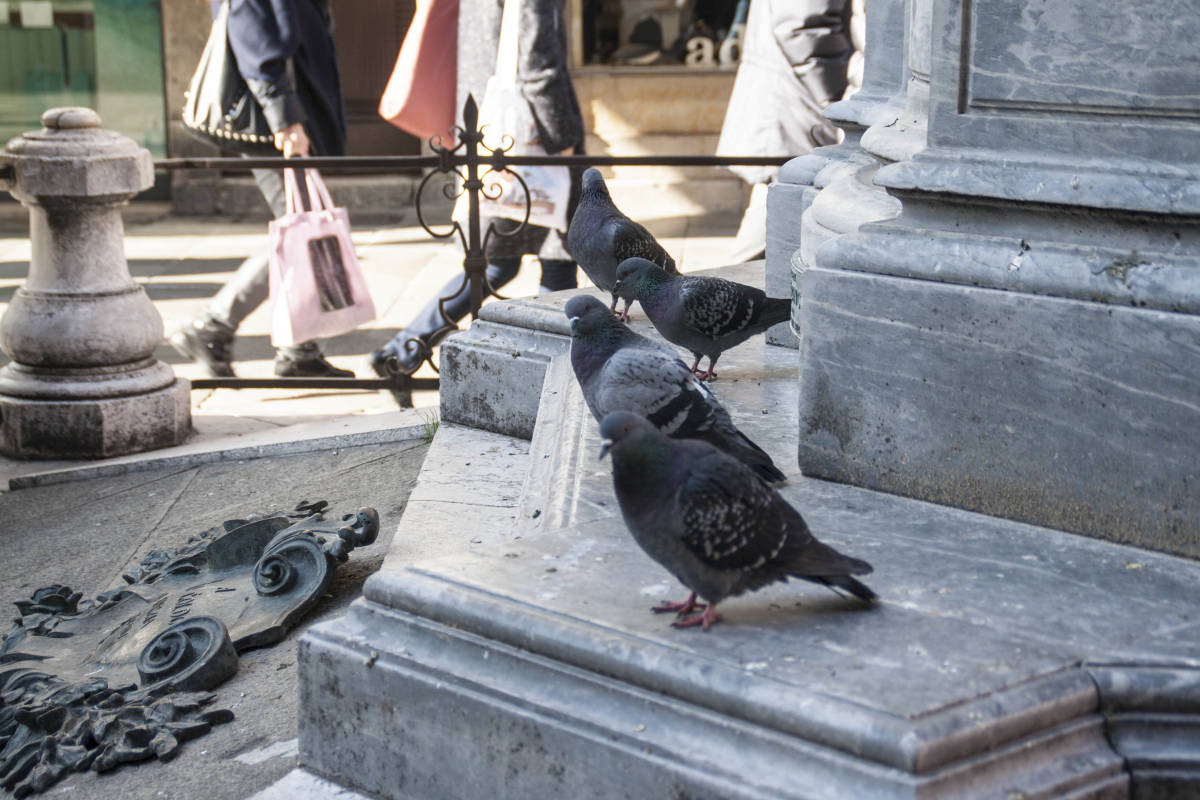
[613,258,792,380]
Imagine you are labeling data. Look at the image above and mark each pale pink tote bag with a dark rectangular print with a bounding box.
[269,169,376,347]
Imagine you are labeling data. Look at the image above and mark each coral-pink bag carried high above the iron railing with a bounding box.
[379,0,458,142]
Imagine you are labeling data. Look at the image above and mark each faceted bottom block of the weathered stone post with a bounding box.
[0,379,192,459]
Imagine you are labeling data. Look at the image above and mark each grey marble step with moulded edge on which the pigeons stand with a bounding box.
[276,269,1200,800]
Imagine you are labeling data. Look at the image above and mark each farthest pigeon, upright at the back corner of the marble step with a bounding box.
[566,167,679,320]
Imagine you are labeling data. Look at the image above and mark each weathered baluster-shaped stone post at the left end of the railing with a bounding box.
[0,108,191,458]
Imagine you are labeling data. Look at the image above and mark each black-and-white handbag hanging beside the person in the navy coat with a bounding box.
[182,0,280,156]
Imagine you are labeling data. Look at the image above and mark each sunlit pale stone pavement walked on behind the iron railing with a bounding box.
[0,203,738,491]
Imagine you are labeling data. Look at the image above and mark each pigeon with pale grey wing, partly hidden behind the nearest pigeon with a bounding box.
[566,295,786,483]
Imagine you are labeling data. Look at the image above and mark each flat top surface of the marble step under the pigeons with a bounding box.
[374,333,1200,705]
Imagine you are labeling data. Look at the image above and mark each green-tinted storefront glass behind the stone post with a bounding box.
[0,0,167,156]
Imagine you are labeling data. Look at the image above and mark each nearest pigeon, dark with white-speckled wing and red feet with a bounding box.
[600,411,876,631]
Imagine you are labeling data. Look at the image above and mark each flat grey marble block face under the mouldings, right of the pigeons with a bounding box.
[799,267,1200,558]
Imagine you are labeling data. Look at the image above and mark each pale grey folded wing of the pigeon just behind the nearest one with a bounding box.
[595,347,719,435]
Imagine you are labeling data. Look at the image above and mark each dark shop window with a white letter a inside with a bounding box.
[571,0,750,70]
